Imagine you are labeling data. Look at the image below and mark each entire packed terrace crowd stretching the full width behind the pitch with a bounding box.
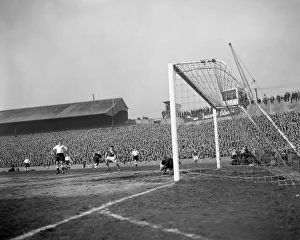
[0,111,300,167]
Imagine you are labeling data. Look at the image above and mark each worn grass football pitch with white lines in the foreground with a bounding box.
[0,163,300,240]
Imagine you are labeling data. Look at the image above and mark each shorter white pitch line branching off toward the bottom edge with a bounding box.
[98,210,208,240]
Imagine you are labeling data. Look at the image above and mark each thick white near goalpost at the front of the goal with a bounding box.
[168,63,180,182]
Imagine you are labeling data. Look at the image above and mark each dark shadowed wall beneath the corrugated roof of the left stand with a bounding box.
[0,111,128,136]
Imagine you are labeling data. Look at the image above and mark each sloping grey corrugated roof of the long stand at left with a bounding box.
[0,98,127,124]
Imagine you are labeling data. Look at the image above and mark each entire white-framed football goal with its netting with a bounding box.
[169,59,300,185]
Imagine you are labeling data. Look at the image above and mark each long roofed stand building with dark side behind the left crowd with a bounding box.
[0,98,128,136]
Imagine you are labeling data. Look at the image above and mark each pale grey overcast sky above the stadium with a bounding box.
[0,0,300,118]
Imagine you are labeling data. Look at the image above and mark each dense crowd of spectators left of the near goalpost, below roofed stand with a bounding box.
[0,124,171,167]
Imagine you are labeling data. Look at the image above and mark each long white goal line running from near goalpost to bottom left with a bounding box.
[12,183,174,240]
